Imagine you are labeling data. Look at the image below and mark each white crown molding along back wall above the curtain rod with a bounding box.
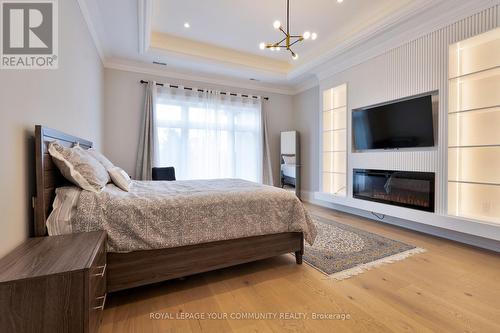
[104,59,296,95]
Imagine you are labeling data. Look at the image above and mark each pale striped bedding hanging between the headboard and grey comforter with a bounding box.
[47,186,82,236]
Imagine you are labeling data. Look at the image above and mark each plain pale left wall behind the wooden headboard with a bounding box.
[0,0,103,257]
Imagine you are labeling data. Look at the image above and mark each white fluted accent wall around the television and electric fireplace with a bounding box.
[294,5,500,244]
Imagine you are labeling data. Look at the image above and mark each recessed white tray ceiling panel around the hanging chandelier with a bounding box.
[152,0,414,63]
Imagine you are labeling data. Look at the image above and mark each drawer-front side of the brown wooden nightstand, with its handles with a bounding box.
[88,235,107,332]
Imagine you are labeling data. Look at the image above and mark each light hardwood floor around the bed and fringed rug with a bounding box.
[100,205,500,333]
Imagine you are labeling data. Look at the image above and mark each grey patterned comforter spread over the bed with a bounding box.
[71,179,316,252]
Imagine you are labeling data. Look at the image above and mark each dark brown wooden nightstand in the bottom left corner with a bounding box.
[0,231,106,333]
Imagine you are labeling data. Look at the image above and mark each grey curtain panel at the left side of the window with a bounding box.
[135,81,156,180]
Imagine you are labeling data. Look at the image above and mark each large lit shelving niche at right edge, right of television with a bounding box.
[448,29,500,223]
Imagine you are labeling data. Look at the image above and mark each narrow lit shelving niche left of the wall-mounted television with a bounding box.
[321,84,347,197]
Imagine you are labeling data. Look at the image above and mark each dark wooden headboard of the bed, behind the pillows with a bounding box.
[33,125,92,236]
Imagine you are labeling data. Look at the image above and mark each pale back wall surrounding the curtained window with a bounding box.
[104,68,294,185]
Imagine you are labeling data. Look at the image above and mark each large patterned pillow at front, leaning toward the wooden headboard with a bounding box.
[49,142,109,192]
